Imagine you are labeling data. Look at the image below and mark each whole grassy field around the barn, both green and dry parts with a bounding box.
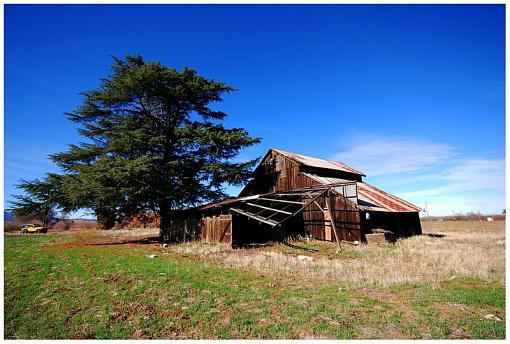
[4,221,505,339]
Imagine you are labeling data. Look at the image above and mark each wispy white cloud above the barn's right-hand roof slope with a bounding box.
[332,135,505,215]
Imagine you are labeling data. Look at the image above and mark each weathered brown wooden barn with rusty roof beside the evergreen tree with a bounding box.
[167,149,421,245]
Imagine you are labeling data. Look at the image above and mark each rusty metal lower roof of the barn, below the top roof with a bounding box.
[303,173,422,212]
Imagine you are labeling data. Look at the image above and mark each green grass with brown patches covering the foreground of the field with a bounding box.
[4,235,505,339]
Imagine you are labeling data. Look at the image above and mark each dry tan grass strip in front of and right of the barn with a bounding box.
[170,221,505,288]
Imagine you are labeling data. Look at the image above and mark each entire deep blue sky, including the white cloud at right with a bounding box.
[4,5,505,215]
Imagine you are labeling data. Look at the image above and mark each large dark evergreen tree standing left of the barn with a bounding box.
[46,56,260,240]
